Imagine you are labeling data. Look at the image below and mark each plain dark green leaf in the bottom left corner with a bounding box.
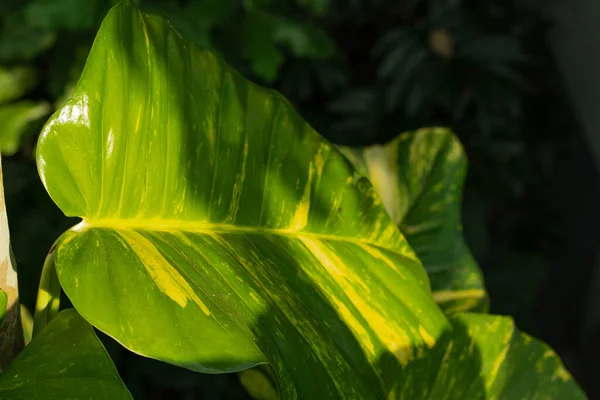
[0,309,131,400]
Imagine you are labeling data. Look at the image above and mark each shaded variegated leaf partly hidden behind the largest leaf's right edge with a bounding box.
[342,128,488,313]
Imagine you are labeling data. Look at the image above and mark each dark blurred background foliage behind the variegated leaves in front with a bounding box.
[0,0,600,399]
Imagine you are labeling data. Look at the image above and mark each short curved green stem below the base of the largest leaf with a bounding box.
[32,250,61,338]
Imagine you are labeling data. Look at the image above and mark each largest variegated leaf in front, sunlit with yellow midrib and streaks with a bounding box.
[37,3,447,399]
